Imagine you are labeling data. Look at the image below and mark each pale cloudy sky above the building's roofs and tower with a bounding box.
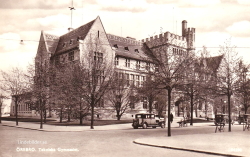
[0,0,250,70]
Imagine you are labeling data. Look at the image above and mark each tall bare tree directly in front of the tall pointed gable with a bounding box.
[78,32,114,129]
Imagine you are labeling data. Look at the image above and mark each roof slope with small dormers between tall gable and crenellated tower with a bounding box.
[107,34,148,60]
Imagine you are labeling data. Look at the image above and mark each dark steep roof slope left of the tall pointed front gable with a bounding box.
[55,19,96,54]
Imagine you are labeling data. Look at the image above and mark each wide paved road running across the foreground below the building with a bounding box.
[0,125,222,157]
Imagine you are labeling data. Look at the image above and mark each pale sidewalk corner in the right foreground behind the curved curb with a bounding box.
[134,131,250,157]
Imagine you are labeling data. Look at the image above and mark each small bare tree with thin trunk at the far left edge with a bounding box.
[0,67,30,125]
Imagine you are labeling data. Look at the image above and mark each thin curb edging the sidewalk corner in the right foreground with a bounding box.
[133,140,242,157]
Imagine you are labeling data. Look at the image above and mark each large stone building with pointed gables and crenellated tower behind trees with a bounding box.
[11,17,212,118]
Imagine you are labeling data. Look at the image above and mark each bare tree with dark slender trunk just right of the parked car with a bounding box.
[144,44,194,136]
